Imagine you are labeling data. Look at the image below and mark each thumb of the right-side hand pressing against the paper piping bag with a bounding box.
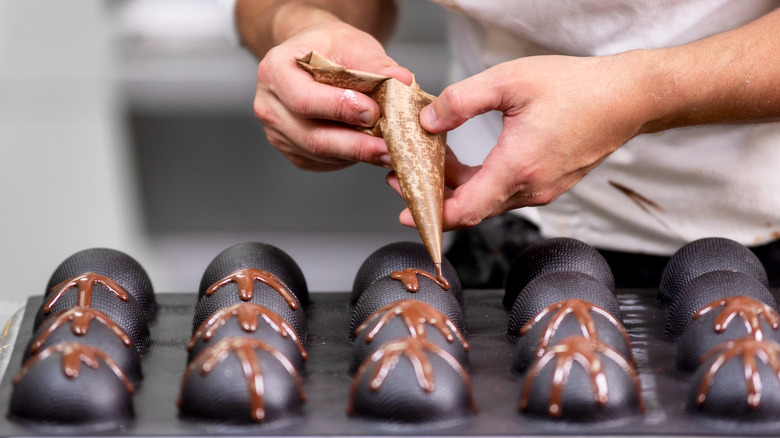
[420,74,501,133]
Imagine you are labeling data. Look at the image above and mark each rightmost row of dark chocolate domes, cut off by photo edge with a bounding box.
[658,238,780,421]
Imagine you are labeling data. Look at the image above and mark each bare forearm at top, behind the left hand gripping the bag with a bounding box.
[235,0,397,58]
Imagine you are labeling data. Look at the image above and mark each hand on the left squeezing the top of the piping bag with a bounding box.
[254,21,412,171]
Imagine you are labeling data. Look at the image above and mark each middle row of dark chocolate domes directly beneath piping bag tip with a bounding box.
[348,242,477,424]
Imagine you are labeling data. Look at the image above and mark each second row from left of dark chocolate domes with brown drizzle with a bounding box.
[179,242,309,424]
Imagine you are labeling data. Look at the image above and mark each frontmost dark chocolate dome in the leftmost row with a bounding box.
[9,344,134,430]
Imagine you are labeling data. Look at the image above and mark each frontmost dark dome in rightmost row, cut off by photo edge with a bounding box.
[687,337,780,421]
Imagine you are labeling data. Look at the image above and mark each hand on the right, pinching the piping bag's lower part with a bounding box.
[388,52,645,230]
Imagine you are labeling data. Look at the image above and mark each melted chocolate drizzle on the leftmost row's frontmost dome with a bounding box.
[13,342,135,394]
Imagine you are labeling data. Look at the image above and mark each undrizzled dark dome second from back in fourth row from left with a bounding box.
[507,271,623,338]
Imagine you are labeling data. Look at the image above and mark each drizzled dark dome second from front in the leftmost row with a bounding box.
[23,309,143,387]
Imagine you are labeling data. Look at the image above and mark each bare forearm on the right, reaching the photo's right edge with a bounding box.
[626,10,780,132]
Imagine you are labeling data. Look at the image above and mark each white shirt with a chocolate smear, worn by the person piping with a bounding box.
[435,0,780,255]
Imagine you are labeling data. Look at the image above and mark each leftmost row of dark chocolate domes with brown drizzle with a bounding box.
[9,248,156,431]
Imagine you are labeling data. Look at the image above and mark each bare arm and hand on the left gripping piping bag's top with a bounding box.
[236,0,412,171]
